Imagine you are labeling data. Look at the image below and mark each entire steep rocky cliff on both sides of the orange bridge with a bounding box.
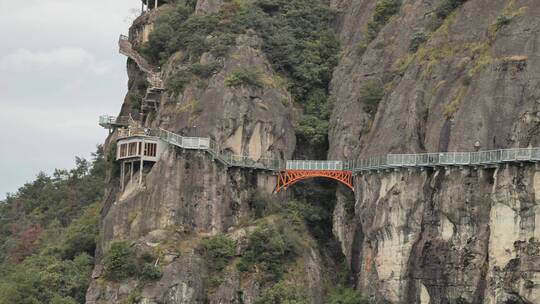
[87,0,540,304]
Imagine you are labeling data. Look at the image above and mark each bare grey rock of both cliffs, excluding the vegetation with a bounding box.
[87,0,540,304]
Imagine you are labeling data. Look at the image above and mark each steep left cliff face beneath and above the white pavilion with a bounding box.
[87,1,323,303]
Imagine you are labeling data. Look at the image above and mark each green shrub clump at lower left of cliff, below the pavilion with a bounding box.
[103,241,139,281]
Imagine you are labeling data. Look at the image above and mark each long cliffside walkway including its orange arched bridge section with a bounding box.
[100,116,540,192]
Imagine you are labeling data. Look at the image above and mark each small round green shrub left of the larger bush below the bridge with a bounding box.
[202,235,236,272]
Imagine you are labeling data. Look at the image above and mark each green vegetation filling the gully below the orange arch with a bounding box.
[236,193,368,304]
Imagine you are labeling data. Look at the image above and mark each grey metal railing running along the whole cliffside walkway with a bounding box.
[105,116,540,172]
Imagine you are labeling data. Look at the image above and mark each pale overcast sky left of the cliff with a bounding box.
[0,0,140,200]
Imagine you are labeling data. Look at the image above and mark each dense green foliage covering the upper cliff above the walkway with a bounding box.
[142,0,339,144]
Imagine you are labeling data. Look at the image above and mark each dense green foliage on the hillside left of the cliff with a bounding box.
[0,148,108,304]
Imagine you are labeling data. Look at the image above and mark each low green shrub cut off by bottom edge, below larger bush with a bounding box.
[253,281,309,304]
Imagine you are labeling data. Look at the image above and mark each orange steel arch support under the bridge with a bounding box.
[276,170,354,192]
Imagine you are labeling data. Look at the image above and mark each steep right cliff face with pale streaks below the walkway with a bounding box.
[329,0,540,303]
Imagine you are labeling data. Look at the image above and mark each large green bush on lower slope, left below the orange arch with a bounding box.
[237,224,296,278]
